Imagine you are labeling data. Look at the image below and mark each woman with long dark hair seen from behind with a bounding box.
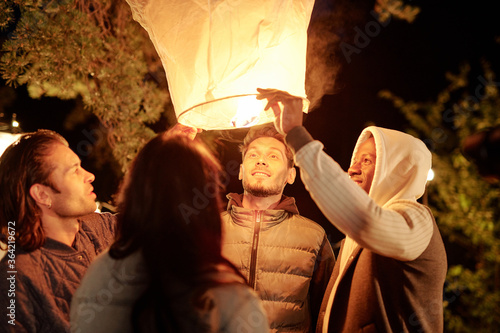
[71,132,268,333]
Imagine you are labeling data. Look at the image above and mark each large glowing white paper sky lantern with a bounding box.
[127,0,314,130]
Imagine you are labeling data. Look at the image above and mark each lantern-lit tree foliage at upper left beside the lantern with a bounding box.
[0,0,169,169]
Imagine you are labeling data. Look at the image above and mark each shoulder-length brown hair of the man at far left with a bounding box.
[0,130,68,252]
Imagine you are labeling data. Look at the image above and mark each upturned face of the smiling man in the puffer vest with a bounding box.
[239,137,295,197]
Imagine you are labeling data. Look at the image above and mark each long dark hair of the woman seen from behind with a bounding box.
[109,132,241,332]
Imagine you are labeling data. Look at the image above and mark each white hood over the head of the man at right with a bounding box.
[351,126,432,206]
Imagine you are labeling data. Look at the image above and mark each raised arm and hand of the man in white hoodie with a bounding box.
[260,90,433,260]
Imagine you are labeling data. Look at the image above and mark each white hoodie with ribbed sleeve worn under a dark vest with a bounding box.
[287,126,433,262]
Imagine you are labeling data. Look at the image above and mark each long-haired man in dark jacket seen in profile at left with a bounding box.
[0,130,115,332]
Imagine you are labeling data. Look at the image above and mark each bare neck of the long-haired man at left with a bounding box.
[42,209,80,246]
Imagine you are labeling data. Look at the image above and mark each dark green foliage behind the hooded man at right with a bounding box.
[380,62,500,332]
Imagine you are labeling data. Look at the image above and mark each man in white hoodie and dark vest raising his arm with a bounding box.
[259,89,447,332]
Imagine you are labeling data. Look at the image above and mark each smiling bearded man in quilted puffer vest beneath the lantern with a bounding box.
[222,125,335,332]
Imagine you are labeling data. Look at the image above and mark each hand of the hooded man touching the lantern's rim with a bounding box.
[257,88,303,135]
